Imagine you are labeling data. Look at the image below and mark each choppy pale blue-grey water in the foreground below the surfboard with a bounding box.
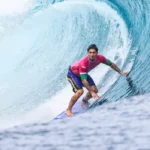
[0,95,150,150]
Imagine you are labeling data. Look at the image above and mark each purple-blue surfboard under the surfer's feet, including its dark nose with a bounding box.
[53,99,107,120]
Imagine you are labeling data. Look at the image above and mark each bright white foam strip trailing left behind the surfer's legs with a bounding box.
[0,84,73,129]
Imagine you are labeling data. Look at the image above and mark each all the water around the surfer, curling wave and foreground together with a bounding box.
[0,0,150,150]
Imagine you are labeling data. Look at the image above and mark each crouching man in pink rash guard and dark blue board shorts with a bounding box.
[65,44,128,116]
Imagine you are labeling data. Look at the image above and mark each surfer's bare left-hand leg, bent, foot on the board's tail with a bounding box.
[65,89,84,116]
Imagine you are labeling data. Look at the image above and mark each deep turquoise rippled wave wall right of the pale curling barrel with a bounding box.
[98,0,150,100]
